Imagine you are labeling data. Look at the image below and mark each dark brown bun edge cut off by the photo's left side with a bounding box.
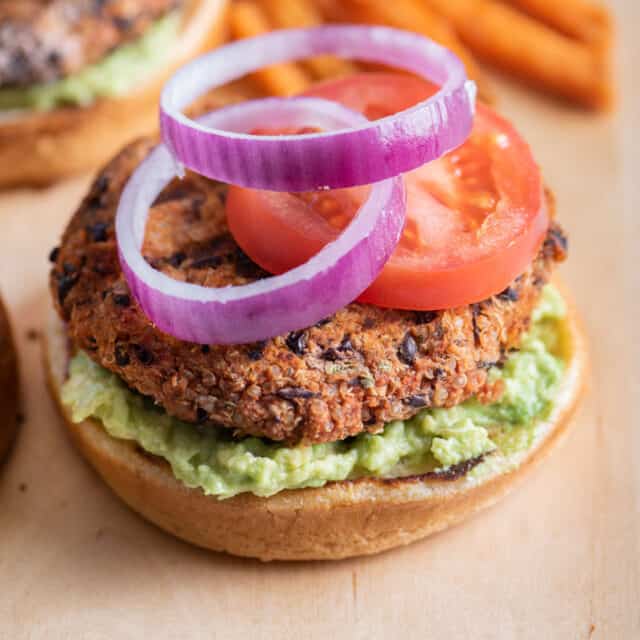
[0,301,18,462]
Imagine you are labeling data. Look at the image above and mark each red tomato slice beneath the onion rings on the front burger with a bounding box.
[227,73,549,310]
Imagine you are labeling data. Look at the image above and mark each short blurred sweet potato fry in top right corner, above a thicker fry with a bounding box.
[508,0,613,47]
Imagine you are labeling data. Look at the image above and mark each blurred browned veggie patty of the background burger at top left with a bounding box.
[0,0,182,87]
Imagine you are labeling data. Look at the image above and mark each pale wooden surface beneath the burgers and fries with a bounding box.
[0,0,640,640]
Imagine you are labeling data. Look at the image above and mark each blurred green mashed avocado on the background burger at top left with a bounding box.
[0,13,180,111]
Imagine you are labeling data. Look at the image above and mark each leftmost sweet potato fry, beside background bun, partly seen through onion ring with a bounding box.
[229,0,311,96]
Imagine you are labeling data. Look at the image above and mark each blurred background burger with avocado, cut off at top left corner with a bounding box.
[0,0,224,187]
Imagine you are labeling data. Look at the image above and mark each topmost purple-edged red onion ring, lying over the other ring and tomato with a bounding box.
[160,25,475,191]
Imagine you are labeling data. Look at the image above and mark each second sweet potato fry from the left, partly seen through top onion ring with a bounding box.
[261,0,357,80]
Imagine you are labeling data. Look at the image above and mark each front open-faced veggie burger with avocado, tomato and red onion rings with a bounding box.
[47,27,585,560]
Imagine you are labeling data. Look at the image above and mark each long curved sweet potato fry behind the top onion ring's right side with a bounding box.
[341,0,493,102]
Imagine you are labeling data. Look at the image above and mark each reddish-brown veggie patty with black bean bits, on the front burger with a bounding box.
[50,141,566,443]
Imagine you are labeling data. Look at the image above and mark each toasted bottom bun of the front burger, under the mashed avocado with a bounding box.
[45,292,586,560]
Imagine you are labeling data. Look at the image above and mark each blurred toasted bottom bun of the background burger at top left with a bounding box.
[0,0,226,188]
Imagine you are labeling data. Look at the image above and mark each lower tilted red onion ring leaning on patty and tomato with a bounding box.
[116,98,405,344]
